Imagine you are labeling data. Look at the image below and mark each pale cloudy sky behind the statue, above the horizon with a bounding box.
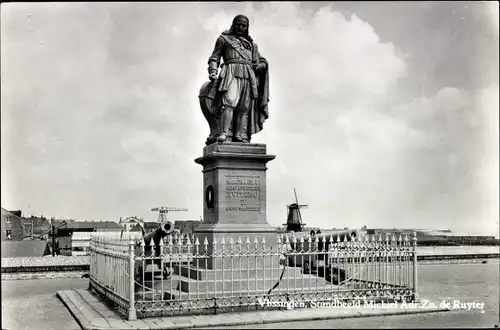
[1,2,499,235]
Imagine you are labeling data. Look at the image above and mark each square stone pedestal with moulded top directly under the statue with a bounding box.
[195,143,277,269]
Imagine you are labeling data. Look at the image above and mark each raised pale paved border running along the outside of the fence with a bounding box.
[58,290,447,330]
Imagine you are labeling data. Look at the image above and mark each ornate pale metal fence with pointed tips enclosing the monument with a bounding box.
[90,232,418,319]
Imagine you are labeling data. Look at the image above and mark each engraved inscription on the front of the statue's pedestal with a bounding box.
[224,175,261,212]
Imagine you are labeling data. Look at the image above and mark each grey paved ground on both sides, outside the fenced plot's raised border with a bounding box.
[2,260,500,330]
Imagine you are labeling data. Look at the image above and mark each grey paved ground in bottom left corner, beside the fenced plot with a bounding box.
[2,279,89,330]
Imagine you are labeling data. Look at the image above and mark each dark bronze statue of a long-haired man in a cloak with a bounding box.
[200,15,269,145]
